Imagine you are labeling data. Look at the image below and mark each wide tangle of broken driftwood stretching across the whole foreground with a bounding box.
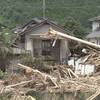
[0,64,100,100]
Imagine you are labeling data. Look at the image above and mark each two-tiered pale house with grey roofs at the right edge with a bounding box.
[86,16,100,45]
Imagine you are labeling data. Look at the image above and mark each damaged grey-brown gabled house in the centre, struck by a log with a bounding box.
[13,18,70,63]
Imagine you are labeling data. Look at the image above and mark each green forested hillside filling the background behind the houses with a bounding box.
[0,0,100,27]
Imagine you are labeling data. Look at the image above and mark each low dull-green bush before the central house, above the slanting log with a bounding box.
[20,54,51,72]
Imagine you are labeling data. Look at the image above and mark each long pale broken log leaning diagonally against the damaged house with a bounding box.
[49,28,100,49]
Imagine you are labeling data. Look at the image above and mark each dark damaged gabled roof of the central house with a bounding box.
[13,18,73,43]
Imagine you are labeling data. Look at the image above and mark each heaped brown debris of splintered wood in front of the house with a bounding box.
[0,64,99,92]
